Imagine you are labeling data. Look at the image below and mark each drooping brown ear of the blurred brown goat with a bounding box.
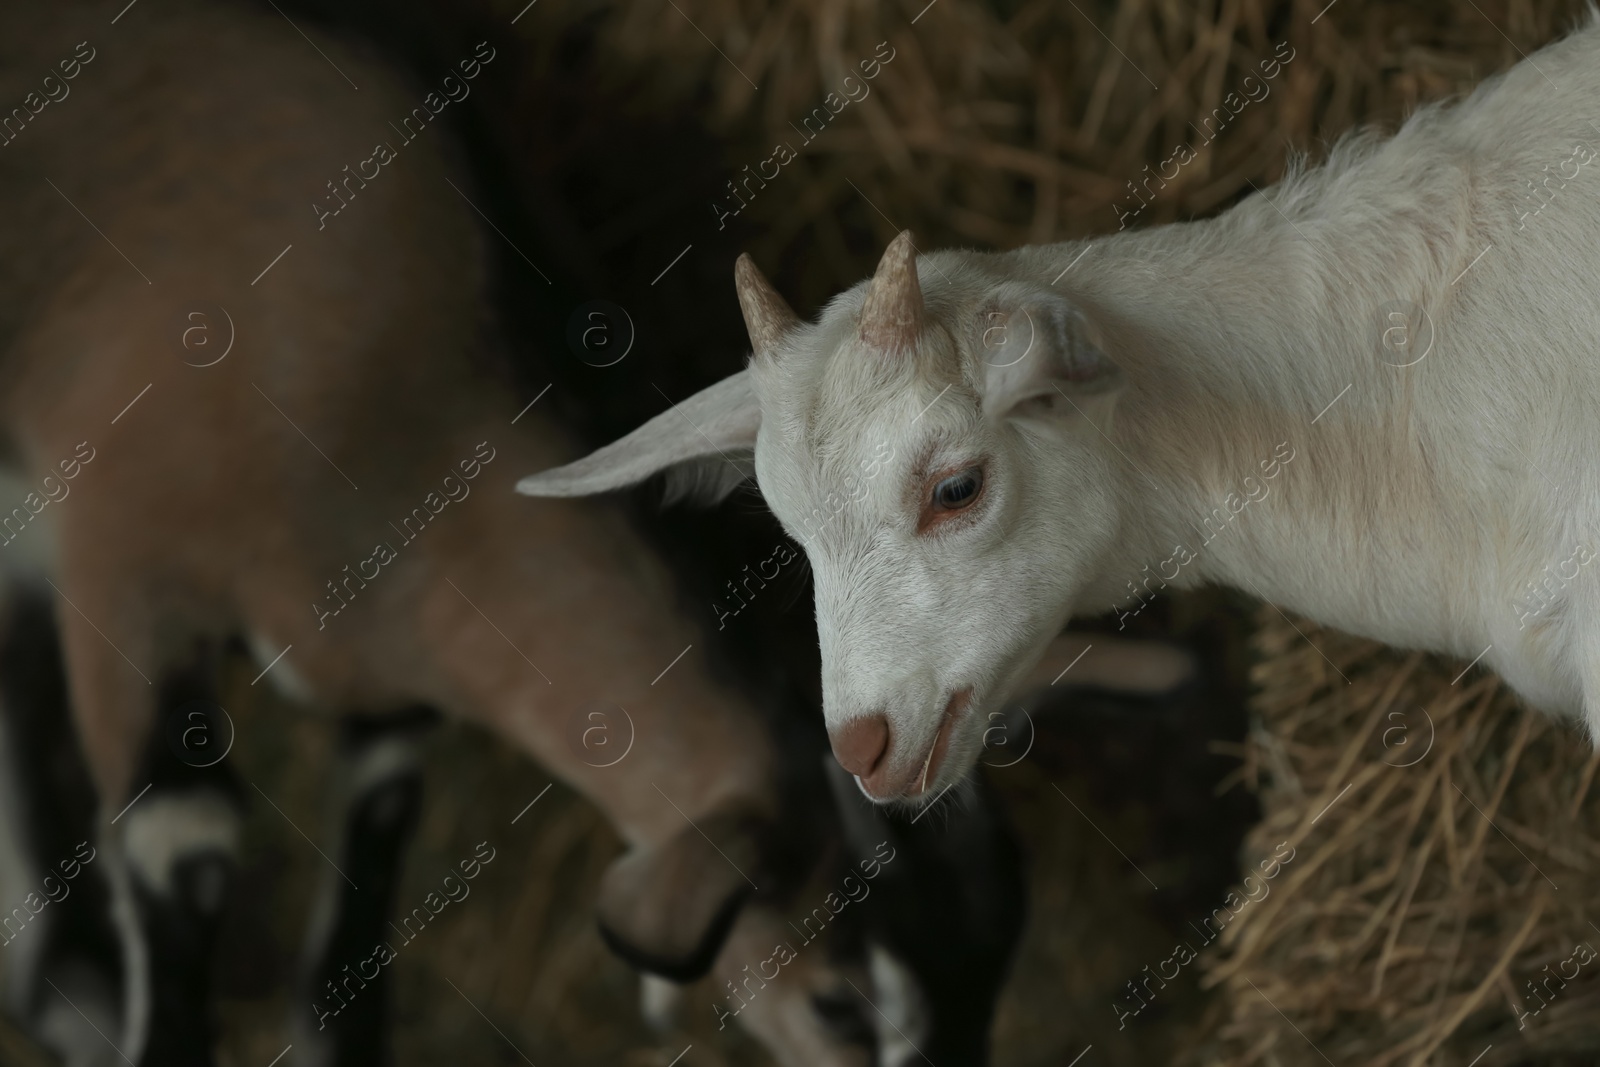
[598,814,760,982]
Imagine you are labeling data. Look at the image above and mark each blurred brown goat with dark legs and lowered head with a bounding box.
[0,0,1004,1067]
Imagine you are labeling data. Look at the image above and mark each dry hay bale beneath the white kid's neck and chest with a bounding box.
[1195,608,1600,1067]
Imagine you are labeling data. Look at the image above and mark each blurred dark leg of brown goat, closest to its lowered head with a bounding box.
[290,709,438,1067]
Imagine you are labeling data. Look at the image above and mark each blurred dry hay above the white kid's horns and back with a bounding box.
[521,0,1581,281]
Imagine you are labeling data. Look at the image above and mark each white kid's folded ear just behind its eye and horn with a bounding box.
[978,298,1123,430]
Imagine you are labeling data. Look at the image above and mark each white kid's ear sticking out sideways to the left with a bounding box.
[517,370,762,501]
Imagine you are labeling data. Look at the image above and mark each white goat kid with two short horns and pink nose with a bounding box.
[518,18,1600,800]
